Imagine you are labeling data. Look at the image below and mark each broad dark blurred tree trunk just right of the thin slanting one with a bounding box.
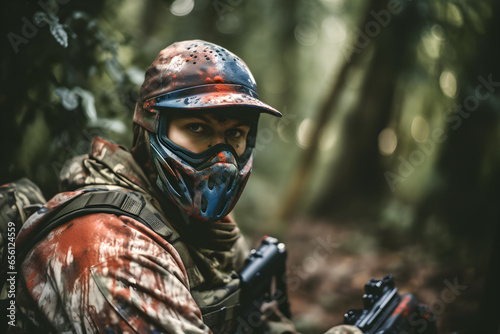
[313,2,422,216]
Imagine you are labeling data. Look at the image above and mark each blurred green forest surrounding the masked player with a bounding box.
[0,0,500,333]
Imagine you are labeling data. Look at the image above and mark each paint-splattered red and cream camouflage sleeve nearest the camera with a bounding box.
[18,214,210,333]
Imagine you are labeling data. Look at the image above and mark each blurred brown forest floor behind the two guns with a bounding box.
[278,220,483,334]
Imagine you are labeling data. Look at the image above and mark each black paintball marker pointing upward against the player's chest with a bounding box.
[236,237,291,334]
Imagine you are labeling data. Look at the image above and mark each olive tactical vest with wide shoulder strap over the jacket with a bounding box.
[18,187,244,333]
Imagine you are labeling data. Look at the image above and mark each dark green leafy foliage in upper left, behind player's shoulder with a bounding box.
[0,0,136,195]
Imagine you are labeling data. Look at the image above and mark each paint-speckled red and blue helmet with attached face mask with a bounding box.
[134,40,281,222]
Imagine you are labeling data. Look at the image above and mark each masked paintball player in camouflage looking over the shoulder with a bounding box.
[16,40,300,333]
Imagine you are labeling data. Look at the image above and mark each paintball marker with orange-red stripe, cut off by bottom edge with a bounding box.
[344,275,437,334]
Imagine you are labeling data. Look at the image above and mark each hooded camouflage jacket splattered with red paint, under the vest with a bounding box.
[16,138,268,333]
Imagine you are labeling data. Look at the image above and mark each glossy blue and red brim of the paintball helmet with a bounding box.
[149,85,283,117]
